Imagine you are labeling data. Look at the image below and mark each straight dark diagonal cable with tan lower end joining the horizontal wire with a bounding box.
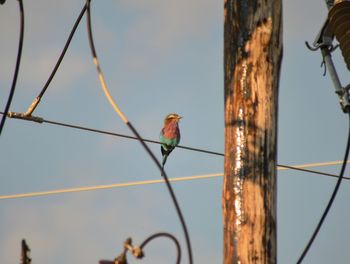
[25,4,86,116]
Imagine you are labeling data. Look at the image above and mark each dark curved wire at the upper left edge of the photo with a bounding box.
[0,0,24,135]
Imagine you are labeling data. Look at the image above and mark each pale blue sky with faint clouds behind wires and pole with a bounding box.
[0,0,350,264]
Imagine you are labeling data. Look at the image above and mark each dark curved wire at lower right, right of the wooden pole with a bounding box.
[297,113,350,264]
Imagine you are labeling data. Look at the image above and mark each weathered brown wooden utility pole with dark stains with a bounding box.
[222,0,282,264]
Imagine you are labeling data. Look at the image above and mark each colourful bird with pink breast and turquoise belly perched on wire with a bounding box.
[159,113,182,174]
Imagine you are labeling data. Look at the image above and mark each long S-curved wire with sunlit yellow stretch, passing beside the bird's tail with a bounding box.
[86,0,193,264]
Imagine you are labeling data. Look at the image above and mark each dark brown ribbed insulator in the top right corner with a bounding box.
[328,1,350,70]
